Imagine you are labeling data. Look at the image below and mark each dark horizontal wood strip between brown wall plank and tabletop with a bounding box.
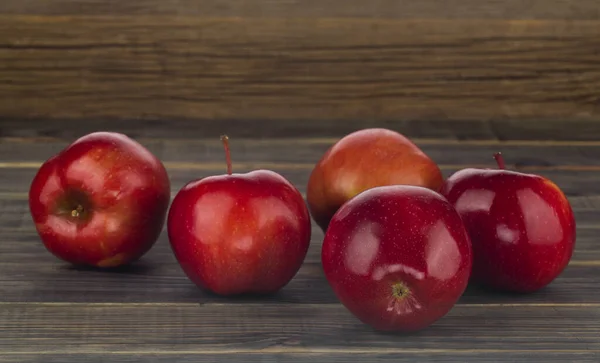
[7,119,600,142]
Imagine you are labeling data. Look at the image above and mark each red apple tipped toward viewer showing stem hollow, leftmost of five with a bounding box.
[29,132,170,268]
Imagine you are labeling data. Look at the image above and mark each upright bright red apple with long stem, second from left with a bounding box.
[167,136,311,295]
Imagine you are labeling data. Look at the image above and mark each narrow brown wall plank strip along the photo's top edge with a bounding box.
[0,0,600,19]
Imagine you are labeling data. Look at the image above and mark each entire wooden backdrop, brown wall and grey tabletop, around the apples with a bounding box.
[0,0,600,363]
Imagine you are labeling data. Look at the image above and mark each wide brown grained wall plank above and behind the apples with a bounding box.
[0,15,600,123]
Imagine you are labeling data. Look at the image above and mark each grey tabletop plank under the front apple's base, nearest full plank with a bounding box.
[0,303,600,357]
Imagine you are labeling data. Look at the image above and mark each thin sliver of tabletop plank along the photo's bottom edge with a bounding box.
[0,349,600,363]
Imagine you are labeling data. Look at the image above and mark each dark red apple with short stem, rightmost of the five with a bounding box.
[441,153,575,293]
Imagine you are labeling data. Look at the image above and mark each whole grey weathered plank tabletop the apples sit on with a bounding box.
[0,132,600,363]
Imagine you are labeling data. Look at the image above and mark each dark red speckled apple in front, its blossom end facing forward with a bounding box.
[321,185,472,332]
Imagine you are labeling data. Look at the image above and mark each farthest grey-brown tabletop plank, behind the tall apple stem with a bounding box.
[5,137,600,170]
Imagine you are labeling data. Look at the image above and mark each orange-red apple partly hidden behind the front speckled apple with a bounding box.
[306,128,444,231]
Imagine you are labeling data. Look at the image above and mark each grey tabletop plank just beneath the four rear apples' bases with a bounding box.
[0,253,600,307]
